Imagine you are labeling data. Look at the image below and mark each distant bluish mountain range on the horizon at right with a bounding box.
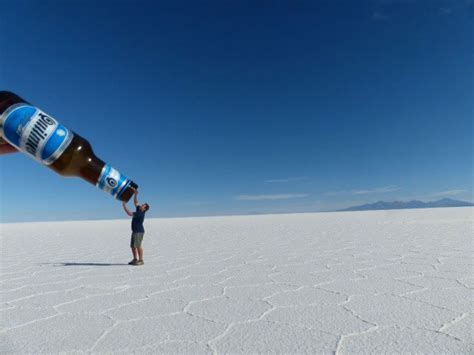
[340,198,474,211]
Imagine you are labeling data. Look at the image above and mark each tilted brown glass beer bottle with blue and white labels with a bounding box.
[0,91,138,202]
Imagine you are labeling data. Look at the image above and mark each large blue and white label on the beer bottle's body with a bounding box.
[0,103,74,165]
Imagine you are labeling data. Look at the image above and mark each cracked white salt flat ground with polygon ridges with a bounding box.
[0,208,474,354]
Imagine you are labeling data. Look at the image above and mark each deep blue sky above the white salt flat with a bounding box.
[0,0,474,222]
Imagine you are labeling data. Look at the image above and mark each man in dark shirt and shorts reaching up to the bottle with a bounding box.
[122,190,150,265]
